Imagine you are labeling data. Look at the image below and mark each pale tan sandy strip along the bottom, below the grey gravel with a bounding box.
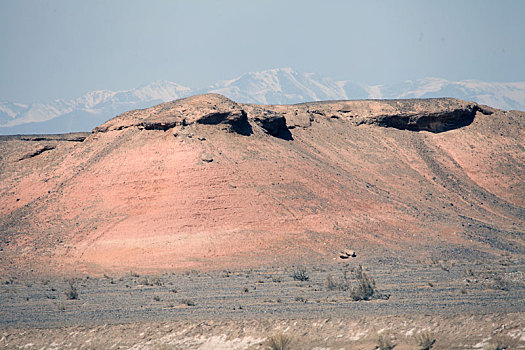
[0,313,525,350]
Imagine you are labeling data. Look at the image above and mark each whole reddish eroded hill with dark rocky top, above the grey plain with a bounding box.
[0,94,525,273]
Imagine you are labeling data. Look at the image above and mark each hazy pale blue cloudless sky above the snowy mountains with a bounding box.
[0,0,525,103]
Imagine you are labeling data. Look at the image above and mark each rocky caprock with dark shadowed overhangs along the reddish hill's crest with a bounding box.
[93,94,493,140]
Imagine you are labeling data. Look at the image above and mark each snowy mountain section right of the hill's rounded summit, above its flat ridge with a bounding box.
[204,68,525,110]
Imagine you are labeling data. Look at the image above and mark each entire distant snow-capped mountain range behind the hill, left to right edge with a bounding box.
[0,68,525,135]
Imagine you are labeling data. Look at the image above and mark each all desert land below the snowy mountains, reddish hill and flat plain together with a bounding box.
[0,94,525,350]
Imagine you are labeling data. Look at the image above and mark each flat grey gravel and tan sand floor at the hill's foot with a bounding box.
[0,256,525,349]
